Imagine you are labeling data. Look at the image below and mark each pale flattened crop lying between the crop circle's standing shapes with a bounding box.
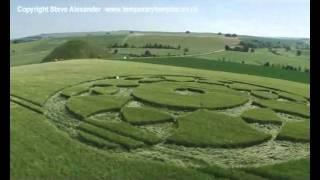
[37,75,310,168]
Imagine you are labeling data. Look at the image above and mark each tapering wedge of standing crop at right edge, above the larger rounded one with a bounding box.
[254,100,310,118]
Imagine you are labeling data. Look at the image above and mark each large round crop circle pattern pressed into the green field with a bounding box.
[45,75,307,168]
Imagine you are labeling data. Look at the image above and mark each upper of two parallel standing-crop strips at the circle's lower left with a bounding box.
[85,120,161,145]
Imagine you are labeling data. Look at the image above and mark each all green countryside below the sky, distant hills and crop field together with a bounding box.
[10,31,310,180]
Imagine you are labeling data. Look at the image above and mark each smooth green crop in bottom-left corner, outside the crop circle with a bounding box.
[10,103,215,180]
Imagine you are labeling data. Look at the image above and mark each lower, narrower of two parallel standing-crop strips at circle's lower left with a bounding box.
[78,123,144,149]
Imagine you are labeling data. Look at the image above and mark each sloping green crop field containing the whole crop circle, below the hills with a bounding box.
[10,59,310,179]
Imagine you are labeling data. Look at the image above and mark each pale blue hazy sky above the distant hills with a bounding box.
[10,0,310,39]
